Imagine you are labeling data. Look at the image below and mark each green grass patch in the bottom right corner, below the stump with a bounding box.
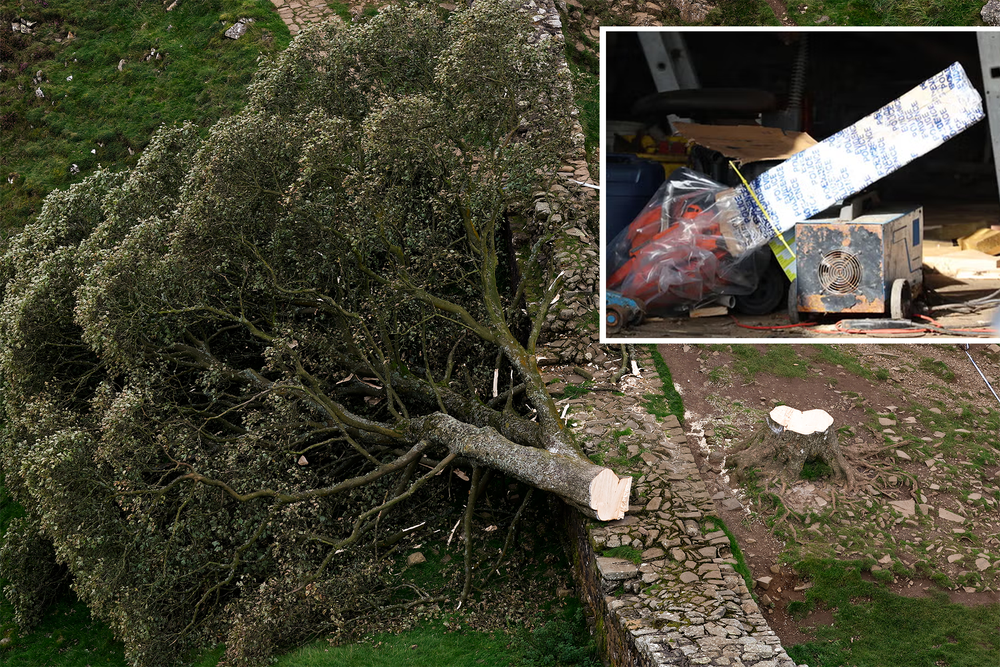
[786,560,1000,667]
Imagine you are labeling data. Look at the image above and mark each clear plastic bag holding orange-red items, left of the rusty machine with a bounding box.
[607,169,760,313]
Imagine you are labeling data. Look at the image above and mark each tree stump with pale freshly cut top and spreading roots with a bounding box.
[727,405,855,489]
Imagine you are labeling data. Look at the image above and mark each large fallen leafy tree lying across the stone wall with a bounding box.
[0,2,631,665]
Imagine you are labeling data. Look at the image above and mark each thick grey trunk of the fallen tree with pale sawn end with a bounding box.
[422,413,632,521]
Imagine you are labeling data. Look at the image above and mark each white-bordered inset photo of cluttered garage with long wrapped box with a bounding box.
[601,28,1000,342]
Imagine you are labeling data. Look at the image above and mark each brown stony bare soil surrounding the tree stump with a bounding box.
[659,345,1000,645]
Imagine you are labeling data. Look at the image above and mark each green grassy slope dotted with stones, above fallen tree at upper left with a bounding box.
[0,0,290,233]
